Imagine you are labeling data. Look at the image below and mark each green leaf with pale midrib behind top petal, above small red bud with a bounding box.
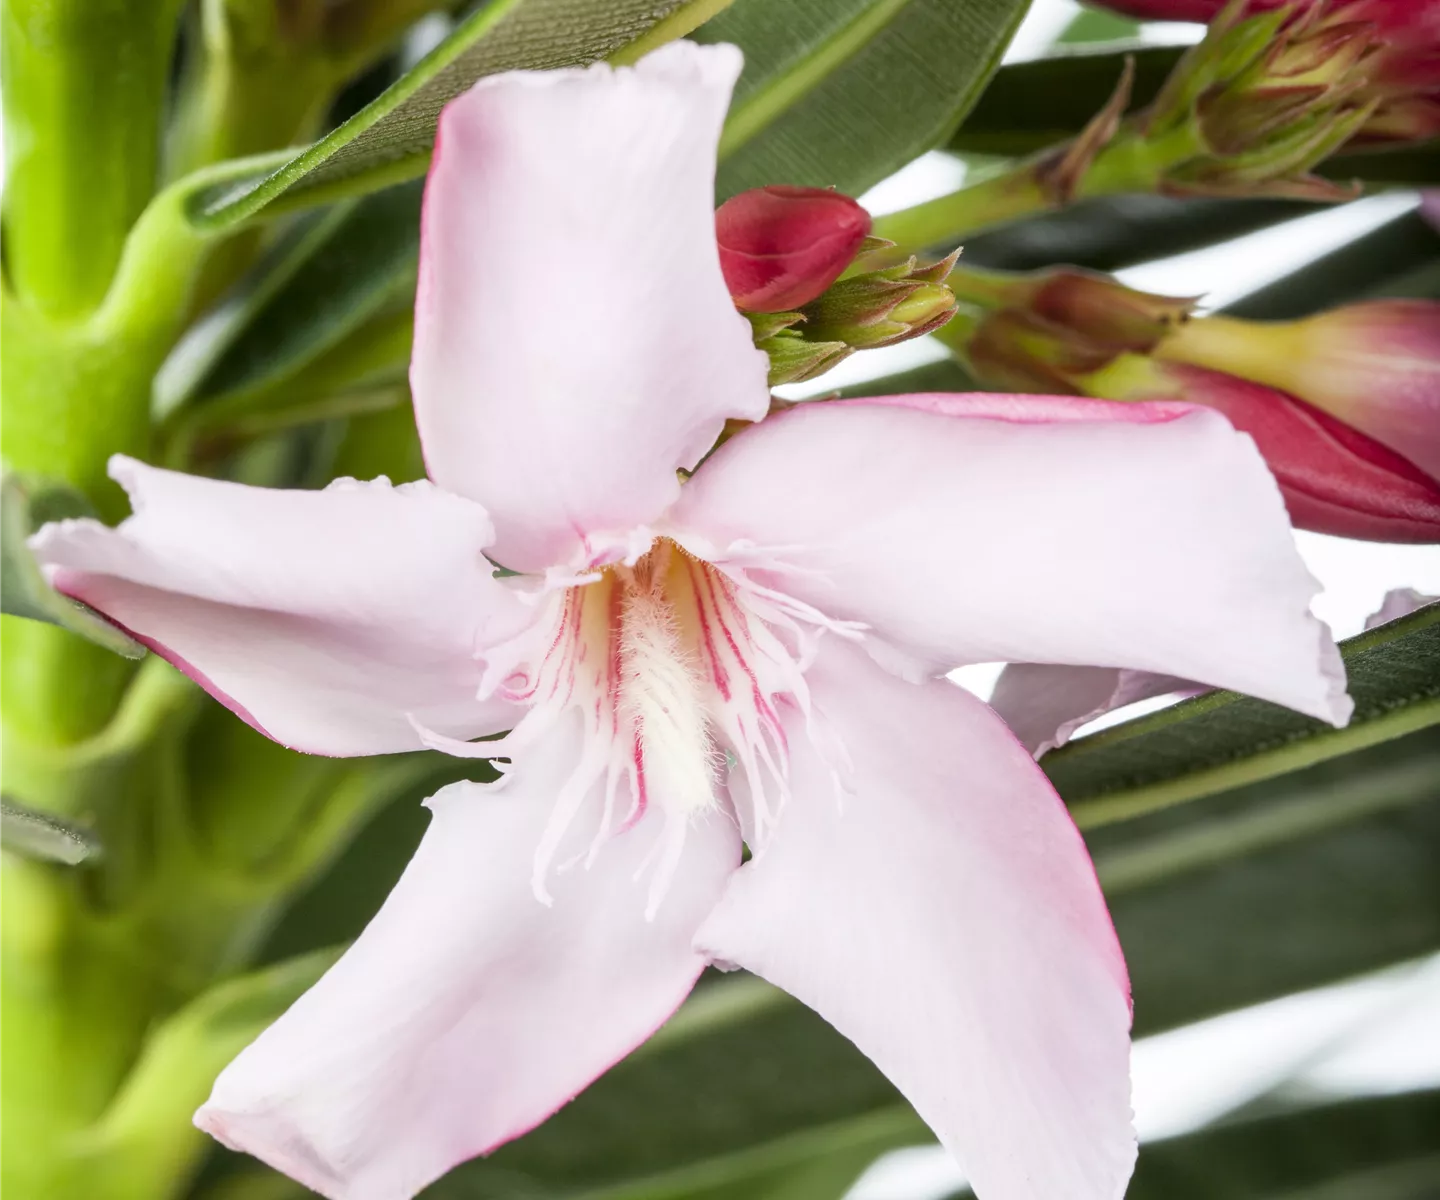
[696,0,1028,199]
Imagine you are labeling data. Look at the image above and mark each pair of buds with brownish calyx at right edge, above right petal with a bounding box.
[942,268,1440,542]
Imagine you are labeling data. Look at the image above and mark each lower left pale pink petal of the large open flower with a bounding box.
[196,720,740,1200]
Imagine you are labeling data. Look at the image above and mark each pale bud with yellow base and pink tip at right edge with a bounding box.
[1155,300,1440,480]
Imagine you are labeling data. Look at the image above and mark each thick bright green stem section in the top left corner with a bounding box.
[0,0,188,321]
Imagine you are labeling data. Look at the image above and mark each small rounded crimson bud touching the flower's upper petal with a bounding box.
[716,186,870,313]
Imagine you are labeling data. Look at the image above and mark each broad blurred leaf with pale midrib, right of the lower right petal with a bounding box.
[1086,729,1440,1034]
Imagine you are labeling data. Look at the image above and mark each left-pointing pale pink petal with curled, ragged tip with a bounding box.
[32,457,531,755]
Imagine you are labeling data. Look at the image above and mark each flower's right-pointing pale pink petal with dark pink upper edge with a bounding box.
[670,396,1349,723]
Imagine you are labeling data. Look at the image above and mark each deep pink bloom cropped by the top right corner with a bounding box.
[1097,0,1440,143]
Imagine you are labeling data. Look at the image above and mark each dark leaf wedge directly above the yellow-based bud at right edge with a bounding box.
[1224,212,1440,321]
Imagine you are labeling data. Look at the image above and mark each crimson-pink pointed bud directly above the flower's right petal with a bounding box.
[1092,356,1440,543]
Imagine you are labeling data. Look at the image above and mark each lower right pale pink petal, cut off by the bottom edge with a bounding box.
[697,638,1135,1200]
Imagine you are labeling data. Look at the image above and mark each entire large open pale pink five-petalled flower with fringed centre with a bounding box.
[33,43,1349,1200]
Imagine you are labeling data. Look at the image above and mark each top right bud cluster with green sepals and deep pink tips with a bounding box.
[1031,0,1440,205]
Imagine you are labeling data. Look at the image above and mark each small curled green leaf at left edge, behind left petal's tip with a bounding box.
[0,464,145,658]
